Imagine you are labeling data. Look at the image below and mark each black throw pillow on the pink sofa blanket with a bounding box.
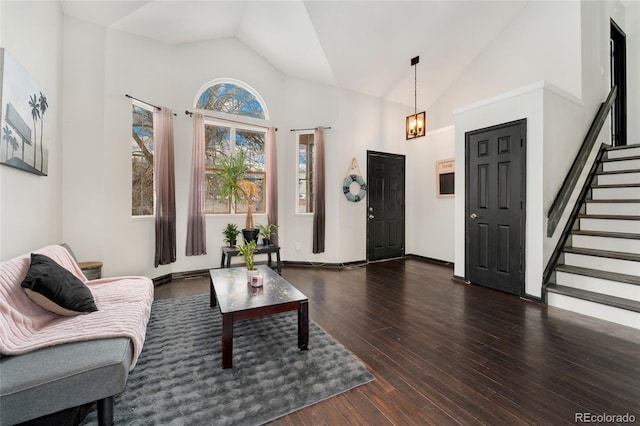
[20,253,98,316]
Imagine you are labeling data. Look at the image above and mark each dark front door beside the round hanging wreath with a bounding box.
[366,151,405,261]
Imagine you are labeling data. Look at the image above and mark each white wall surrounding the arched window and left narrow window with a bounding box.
[65,30,284,277]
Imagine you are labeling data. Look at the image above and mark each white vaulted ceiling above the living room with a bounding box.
[61,0,527,109]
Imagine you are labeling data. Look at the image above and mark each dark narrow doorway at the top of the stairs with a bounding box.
[610,20,627,146]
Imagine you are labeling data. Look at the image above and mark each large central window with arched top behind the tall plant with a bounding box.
[196,81,267,214]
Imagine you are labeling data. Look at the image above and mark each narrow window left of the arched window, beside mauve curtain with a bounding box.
[131,102,154,216]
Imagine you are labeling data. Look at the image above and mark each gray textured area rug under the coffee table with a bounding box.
[83,294,373,425]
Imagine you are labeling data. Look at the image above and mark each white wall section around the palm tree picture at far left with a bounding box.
[0,2,62,260]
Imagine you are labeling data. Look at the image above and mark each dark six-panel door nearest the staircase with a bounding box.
[465,120,526,295]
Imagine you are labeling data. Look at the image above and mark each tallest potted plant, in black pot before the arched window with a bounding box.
[216,150,259,242]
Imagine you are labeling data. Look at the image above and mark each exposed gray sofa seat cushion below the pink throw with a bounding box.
[0,337,133,425]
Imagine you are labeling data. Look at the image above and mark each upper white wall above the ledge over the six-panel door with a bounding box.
[423,1,583,129]
